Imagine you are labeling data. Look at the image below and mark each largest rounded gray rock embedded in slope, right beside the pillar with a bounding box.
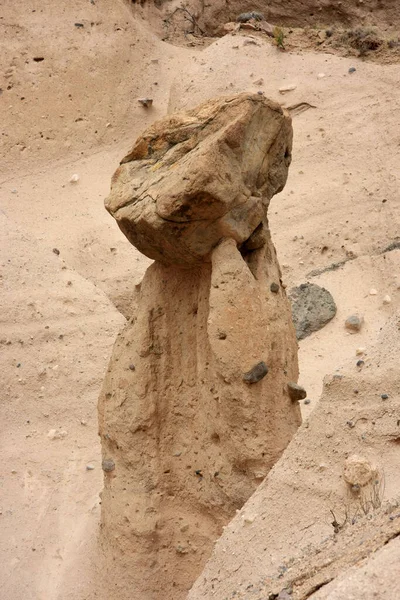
[289,283,336,340]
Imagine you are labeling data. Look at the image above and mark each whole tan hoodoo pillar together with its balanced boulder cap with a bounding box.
[99,94,301,600]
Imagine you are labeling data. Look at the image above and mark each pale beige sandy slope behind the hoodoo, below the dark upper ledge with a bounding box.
[0,0,400,600]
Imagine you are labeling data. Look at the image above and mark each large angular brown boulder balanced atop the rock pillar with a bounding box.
[106,94,292,266]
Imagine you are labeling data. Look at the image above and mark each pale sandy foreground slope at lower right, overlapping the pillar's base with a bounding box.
[188,315,400,600]
